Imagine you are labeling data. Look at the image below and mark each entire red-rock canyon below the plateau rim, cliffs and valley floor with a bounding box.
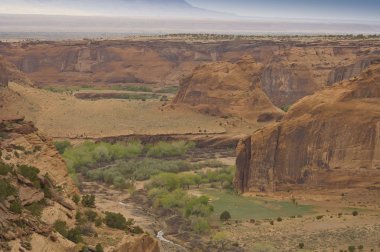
[0,35,380,252]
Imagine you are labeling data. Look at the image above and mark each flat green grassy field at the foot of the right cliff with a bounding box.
[201,189,313,220]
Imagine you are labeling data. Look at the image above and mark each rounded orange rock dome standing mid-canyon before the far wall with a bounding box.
[173,56,282,120]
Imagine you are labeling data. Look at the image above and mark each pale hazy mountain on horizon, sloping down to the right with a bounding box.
[0,0,233,19]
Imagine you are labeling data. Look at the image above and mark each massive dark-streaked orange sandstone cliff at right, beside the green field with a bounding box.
[235,65,380,192]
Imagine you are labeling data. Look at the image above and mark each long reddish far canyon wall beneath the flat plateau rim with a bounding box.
[0,38,380,107]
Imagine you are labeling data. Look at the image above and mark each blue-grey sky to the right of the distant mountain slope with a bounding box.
[188,0,380,20]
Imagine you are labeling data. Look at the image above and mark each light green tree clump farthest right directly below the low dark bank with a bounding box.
[146,141,195,158]
